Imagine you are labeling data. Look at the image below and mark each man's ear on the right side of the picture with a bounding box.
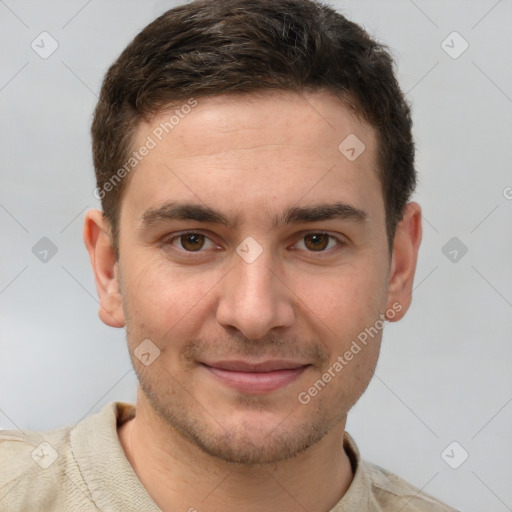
[387,202,422,322]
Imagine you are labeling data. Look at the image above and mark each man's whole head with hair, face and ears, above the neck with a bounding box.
[84,0,421,464]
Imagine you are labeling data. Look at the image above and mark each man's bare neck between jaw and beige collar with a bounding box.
[118,394,353,512]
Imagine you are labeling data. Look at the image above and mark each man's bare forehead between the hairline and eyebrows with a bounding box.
[123,92,381,229]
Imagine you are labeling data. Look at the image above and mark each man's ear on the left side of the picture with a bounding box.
[83,210,125,327]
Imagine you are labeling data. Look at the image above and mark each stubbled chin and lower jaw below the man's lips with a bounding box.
[139,366,343,466]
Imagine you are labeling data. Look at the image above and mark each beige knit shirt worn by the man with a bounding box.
[0,402,456,512]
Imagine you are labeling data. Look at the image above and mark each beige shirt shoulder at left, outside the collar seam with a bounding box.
[0,426,94,512]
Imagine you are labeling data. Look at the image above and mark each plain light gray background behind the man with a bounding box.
[0,0,512,512]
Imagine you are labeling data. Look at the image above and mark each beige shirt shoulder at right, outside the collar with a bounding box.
[360,460,457,512]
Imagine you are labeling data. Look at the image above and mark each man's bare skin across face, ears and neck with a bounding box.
[84,92,421,512]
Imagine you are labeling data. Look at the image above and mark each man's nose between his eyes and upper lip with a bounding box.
[217,244,295,340]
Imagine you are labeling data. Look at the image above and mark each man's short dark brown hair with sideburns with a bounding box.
[91,0,416,259]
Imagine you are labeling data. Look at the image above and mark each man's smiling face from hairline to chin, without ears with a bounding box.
[94,93,401,464]
